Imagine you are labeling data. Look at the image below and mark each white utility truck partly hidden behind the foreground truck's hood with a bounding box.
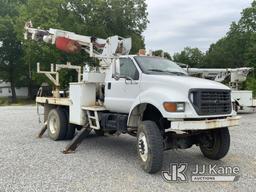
[183,65,256,112]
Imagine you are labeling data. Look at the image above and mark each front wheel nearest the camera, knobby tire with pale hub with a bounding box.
[137,121,163,173]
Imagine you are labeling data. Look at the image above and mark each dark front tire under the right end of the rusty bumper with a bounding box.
[199,128,230,160]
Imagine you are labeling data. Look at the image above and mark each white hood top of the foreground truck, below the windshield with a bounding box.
[143,75,230,90]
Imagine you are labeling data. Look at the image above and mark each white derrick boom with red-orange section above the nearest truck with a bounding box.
[24,21,132,59]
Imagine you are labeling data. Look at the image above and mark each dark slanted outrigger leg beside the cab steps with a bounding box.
[62,127,91,154]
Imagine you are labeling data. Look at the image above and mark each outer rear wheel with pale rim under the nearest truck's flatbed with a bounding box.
[47,109,68,141]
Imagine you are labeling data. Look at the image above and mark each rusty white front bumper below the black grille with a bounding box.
[167,116,241,131]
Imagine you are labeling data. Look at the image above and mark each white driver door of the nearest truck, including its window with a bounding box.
[105,58,140,113]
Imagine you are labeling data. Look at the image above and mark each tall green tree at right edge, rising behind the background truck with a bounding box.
[205,1,256,68]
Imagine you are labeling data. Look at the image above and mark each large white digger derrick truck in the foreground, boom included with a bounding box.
[25,23,240,173]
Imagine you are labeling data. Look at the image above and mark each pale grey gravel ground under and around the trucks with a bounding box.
[0,106,256,192]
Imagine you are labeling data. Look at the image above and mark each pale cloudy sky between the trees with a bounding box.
[143,0,252,54]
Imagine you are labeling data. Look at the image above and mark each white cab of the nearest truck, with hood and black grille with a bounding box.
[104,55,236,120]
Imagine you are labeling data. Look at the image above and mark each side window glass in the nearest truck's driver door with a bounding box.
[120,58,139,80]
